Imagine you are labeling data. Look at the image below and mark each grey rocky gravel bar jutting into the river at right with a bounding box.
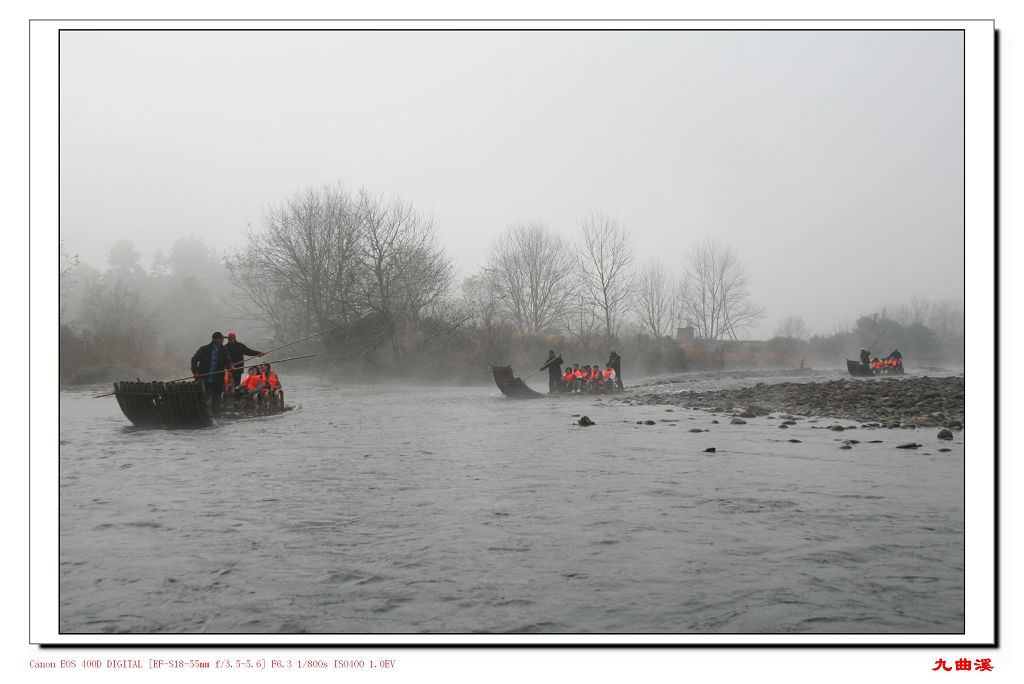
[625,376,964,430]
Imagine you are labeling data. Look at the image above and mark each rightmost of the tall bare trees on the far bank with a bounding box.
[679,240,764,340]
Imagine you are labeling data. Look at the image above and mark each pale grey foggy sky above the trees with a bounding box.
[60,31,964,337]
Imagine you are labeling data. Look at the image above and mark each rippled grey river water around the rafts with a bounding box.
[59,374,965,634]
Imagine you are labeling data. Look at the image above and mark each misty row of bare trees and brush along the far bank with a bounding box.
[60,185,962,382]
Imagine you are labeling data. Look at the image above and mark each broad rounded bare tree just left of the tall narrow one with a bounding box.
[485,222,573,333]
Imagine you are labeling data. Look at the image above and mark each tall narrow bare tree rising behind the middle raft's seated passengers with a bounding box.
[578,214,635,341]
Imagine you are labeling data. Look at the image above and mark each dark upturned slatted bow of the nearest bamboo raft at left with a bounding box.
[114,381,212,427]
